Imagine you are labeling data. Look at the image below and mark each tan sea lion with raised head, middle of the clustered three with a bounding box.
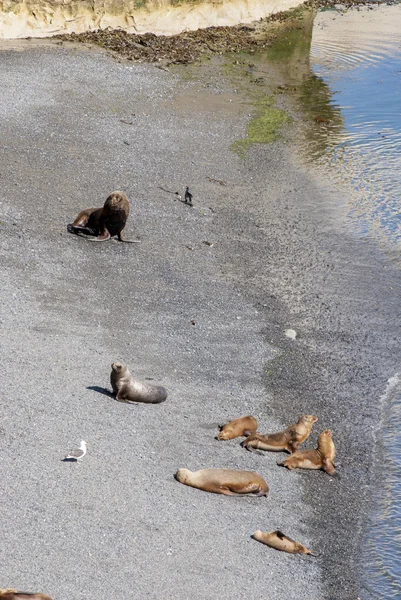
[241,415,317,454]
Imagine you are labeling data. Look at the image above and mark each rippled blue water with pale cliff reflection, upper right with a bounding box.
[309,4,401,246]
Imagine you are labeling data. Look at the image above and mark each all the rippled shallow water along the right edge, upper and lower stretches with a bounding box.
[305,5,401,600]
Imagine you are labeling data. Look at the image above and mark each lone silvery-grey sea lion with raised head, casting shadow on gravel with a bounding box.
[110,362,167,404]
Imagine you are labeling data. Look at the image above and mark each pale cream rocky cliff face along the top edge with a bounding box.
[0,0,303,39]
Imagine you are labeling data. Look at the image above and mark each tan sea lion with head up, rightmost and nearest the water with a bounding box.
[278,429,336,475]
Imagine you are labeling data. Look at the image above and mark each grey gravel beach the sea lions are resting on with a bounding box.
[0,39,401,600]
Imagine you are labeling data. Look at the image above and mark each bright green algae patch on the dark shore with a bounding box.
[230,96,292,158]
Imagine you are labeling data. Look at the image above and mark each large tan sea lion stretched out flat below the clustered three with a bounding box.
[175,469,269,496]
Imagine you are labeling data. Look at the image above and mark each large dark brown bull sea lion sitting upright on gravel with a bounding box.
[67,191,140,244]
